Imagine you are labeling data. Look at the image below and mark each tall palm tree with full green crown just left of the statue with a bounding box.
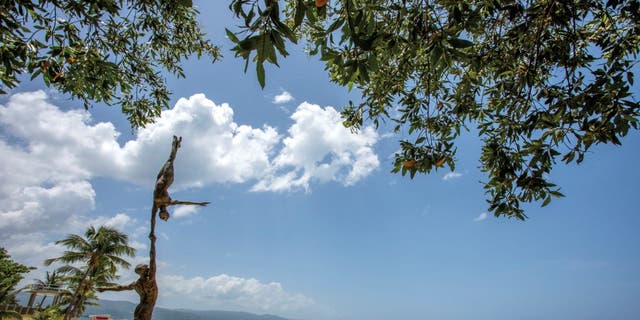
[44,226,135,320]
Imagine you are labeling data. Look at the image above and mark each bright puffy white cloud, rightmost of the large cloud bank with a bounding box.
[252,102,380,191]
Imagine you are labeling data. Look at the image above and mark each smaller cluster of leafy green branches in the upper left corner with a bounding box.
[0,0,220,127]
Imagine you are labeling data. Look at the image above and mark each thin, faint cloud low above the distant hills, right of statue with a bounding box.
[158,274,314,314]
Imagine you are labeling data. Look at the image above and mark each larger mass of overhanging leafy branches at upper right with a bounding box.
[227,0,640,219]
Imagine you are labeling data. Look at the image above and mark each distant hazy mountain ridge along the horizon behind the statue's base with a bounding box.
[84,300,290,320]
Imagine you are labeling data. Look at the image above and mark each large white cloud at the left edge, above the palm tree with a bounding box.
[0,91,123,250]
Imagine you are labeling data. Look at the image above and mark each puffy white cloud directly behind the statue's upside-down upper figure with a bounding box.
[122,94,280,189]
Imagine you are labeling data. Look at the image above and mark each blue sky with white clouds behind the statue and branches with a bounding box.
[0,1,640,320]
